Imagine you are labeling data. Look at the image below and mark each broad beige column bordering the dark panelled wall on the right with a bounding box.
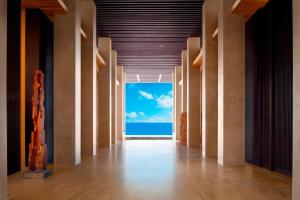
[218,0,245,165]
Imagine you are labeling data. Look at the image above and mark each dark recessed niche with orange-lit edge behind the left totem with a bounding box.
[25,9,53,165]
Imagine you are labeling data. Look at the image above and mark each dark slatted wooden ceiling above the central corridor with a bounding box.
[95,0,204,81]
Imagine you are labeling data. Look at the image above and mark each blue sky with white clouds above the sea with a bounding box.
[126,83,173,123]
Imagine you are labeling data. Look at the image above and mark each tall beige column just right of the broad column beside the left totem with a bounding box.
[80,0,97,156]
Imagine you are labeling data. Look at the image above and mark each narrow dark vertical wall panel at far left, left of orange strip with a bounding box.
[7,0,21,174]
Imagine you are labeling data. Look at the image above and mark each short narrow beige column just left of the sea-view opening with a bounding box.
[116,66,124,141]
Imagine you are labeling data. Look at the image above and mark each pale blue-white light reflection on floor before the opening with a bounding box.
[122,141,176,190]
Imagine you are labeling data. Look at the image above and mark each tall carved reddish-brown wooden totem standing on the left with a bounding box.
[29,70,47,171]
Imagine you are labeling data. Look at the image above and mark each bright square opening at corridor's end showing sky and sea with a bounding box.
[125,83,174,137]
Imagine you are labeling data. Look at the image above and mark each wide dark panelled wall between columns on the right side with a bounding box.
[246,0,292,174]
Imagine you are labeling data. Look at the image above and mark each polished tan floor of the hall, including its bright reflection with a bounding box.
[9,140,291,200]
